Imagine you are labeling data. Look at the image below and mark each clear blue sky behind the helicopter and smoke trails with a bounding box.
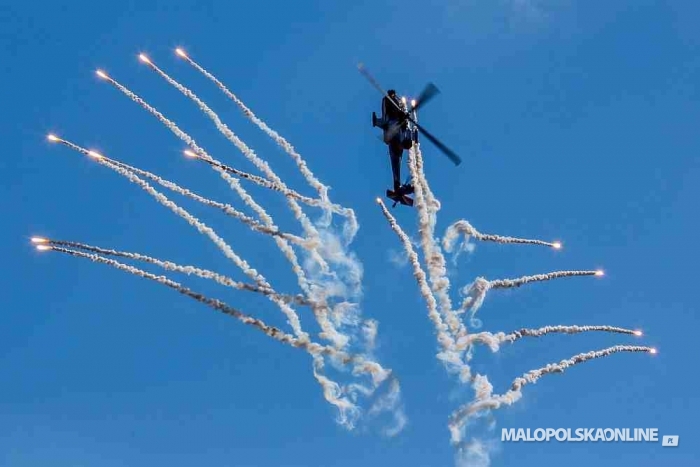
[0,0,700,467]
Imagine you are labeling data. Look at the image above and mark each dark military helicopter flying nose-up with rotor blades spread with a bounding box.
[358,63,462,207]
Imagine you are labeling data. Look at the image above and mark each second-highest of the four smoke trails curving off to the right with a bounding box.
[457,270,603,327]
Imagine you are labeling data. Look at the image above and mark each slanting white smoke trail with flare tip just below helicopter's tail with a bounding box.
[377,198,468,372]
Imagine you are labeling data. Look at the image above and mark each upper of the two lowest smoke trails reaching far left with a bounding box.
[45,238,314,306]
